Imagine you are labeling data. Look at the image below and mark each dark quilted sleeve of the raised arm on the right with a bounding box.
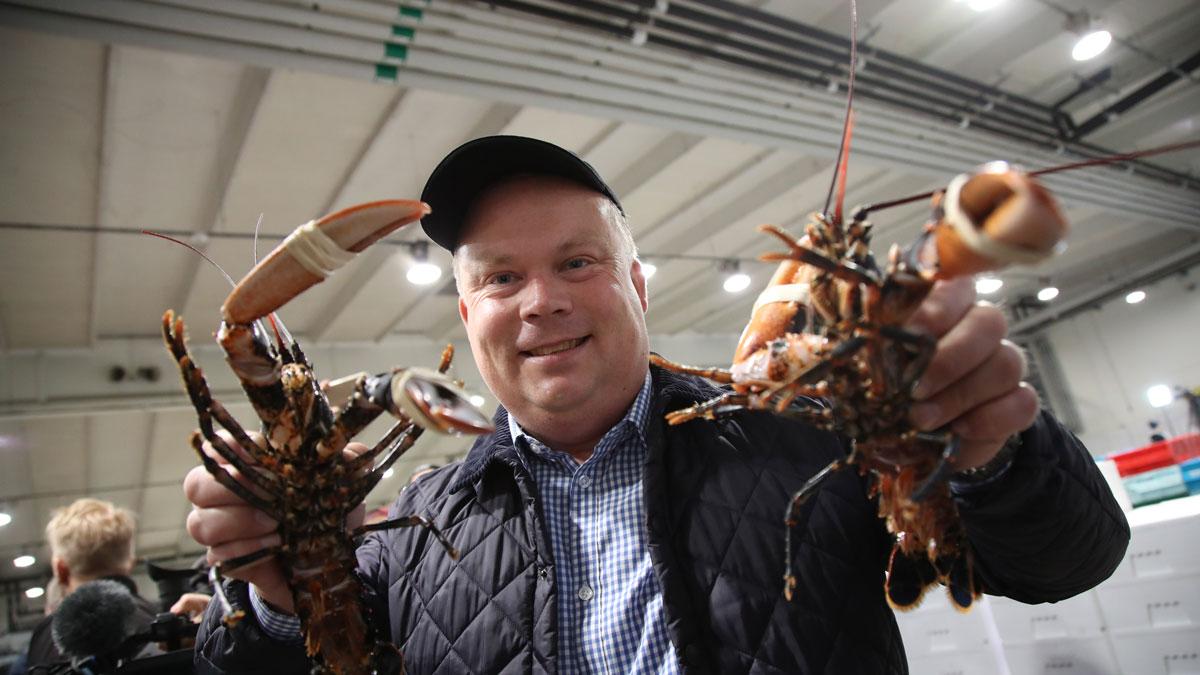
[955,411,1129,603]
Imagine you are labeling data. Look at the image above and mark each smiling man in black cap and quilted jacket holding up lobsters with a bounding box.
[185,137,1129,673]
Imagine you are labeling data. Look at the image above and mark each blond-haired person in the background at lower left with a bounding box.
[29,498,155,669]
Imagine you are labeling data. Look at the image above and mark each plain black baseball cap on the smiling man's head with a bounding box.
[421,136,625,251]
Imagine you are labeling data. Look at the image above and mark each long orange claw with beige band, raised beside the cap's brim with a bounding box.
[221,199,430,324]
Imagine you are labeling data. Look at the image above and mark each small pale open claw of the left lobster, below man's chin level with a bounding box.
[391,368,496,435]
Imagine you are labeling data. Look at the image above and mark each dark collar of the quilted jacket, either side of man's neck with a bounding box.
[450,366,721,494]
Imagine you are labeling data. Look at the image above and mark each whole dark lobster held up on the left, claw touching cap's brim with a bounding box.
[162,201,492,675]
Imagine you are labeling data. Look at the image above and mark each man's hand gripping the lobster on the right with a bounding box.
[906,277,1038,471]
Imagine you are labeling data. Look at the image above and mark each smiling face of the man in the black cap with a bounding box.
[455,177,649,424]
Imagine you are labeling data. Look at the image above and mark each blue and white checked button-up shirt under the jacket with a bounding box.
[250,370,678,675]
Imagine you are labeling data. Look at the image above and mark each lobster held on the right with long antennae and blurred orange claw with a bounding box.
[650,1,1196,611]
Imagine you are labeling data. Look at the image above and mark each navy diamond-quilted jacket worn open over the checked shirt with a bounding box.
[197,369,1129,674]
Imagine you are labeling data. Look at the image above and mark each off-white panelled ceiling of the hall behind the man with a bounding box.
[0,0,1200,588]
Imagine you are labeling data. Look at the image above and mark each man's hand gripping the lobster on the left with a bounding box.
[184,431,367,613]
